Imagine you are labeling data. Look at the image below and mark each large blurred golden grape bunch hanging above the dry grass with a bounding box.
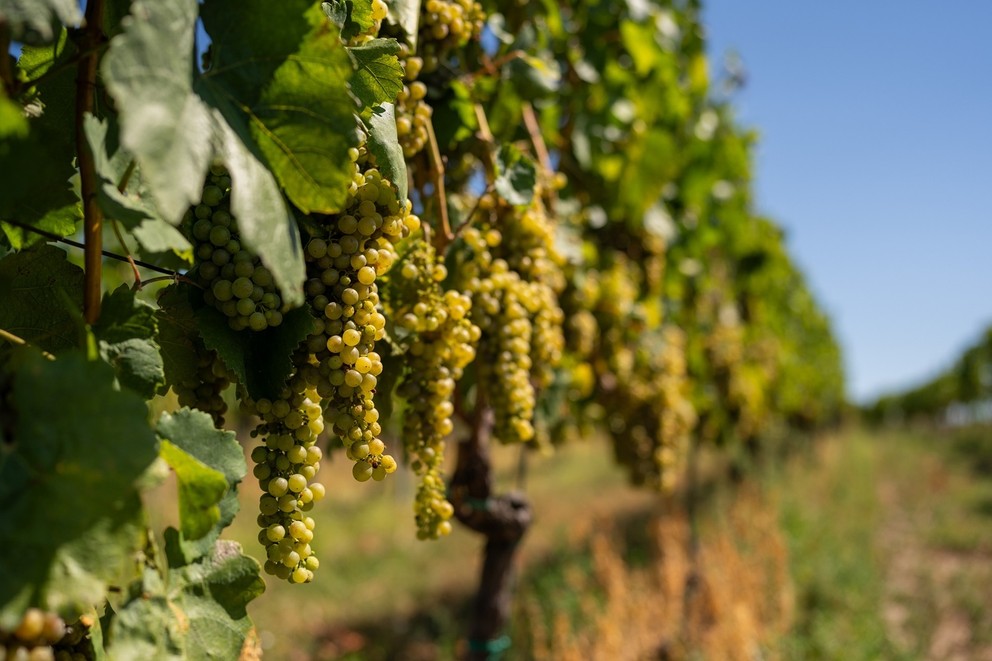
[558,246,696,490]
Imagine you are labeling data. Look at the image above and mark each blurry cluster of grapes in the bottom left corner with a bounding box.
[0,608,94,661]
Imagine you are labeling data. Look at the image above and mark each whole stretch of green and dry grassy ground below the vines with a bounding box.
[205,430,992,661]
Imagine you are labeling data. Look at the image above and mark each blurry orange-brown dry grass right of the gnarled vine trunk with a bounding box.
[517,484,792,661]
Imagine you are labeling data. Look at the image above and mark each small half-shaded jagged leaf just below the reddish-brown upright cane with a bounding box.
[93,285,165,399]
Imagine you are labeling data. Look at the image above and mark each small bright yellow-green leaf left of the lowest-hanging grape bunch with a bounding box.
[159,440,227,539]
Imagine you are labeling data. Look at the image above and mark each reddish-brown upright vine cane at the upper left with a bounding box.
[75,0,104,325]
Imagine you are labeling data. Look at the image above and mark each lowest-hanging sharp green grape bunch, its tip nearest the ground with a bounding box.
[242,374,324,583]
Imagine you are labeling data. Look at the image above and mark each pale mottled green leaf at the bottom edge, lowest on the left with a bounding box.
[108,541,265,661]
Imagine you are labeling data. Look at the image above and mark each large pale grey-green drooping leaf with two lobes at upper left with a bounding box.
[103,0,305,303]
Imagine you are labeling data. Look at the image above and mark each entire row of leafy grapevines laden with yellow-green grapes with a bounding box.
[0,0,844,659]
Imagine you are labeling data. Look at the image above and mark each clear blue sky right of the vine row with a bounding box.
[703,0,992,400]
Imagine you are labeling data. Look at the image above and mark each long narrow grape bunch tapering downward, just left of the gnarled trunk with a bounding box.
[389,237,481,539]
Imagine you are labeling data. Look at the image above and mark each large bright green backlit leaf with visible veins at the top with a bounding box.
[197,0,358,214]
